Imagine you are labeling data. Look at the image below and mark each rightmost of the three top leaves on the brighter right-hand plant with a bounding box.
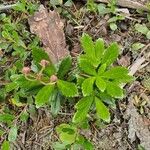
[102,43,119,66]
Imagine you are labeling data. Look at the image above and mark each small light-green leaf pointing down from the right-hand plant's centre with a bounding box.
[96,77,106,92]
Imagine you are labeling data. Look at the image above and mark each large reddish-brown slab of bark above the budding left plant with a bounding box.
[28,5,69,64]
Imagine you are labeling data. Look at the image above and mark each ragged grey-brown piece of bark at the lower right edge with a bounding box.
[126,98,150,150]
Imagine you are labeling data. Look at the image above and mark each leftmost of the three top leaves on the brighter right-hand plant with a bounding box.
[81,33,95,58]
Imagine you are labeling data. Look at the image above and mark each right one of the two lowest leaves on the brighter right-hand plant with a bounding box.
[95,97,110,123]
